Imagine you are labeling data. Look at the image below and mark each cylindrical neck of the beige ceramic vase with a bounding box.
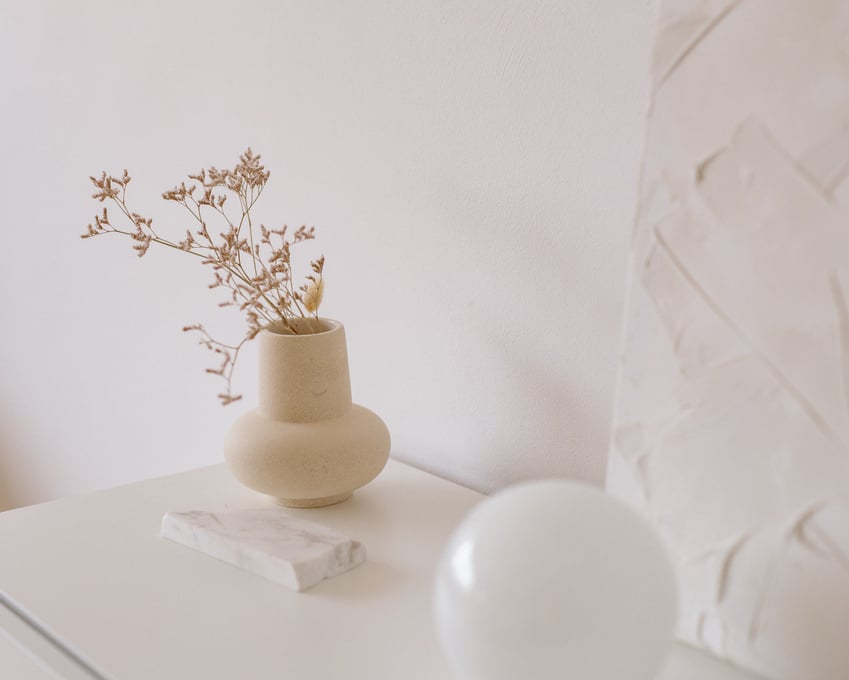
[258,319,351,423]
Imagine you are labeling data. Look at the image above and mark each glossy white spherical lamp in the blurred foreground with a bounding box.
[434,480,676,680]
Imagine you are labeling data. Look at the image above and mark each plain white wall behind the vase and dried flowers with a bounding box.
[0,0,653,505]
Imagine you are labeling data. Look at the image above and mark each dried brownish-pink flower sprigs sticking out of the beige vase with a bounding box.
[82,148,324,406]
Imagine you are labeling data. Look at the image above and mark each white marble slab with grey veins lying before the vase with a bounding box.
[162,508,366,591]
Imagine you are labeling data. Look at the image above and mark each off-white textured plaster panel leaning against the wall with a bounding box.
[607,0,849,680]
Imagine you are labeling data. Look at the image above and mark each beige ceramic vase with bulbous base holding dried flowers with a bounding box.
[224,319,389,508]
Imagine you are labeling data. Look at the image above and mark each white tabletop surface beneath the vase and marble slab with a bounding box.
[0,461,752,680]
